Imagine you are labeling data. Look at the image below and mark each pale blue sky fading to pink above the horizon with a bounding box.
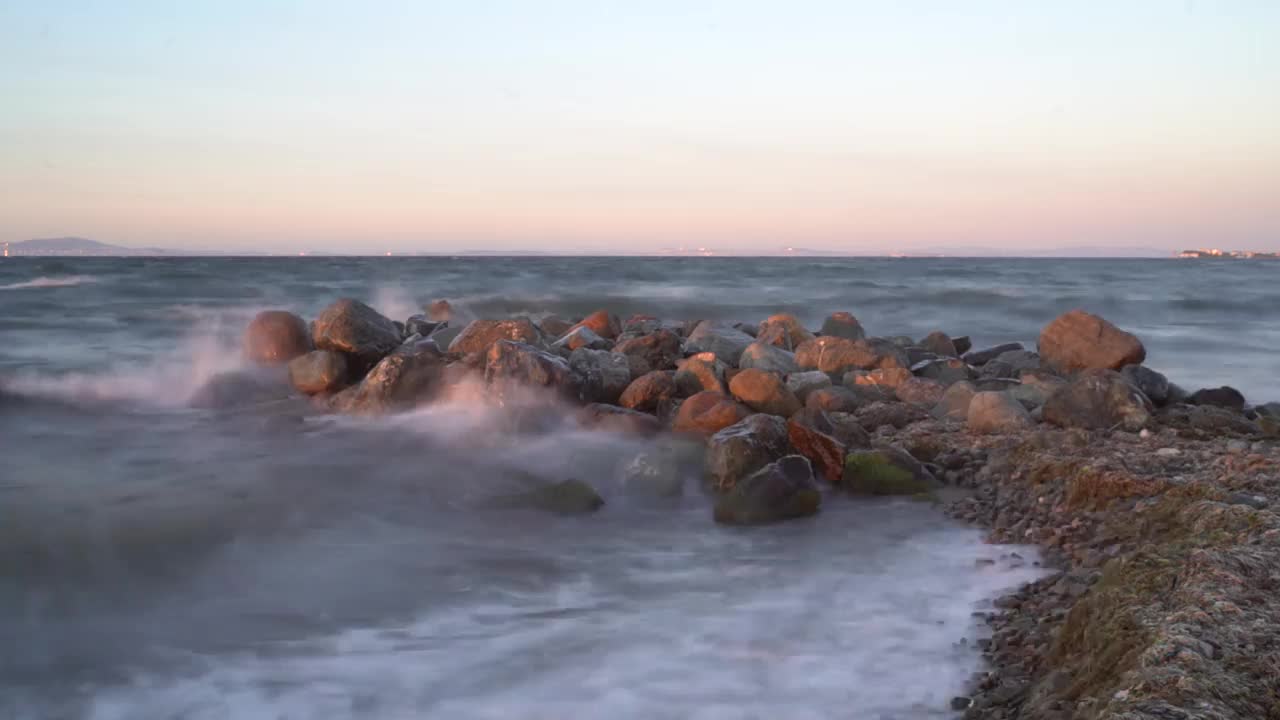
[0,0,1280,252]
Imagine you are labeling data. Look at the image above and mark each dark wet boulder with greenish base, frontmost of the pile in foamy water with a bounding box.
[714,455,822,525]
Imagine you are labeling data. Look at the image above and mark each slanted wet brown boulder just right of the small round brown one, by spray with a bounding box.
[329,341,445,415]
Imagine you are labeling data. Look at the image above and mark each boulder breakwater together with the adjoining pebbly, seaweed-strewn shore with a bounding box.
[212,300,1280,720]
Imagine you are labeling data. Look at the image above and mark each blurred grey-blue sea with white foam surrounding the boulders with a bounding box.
[0,258,1280,720]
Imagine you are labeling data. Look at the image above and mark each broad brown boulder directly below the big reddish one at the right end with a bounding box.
[1043,369,1151,430]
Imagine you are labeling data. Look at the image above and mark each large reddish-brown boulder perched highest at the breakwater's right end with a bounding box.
[1039,310,1147,373]
